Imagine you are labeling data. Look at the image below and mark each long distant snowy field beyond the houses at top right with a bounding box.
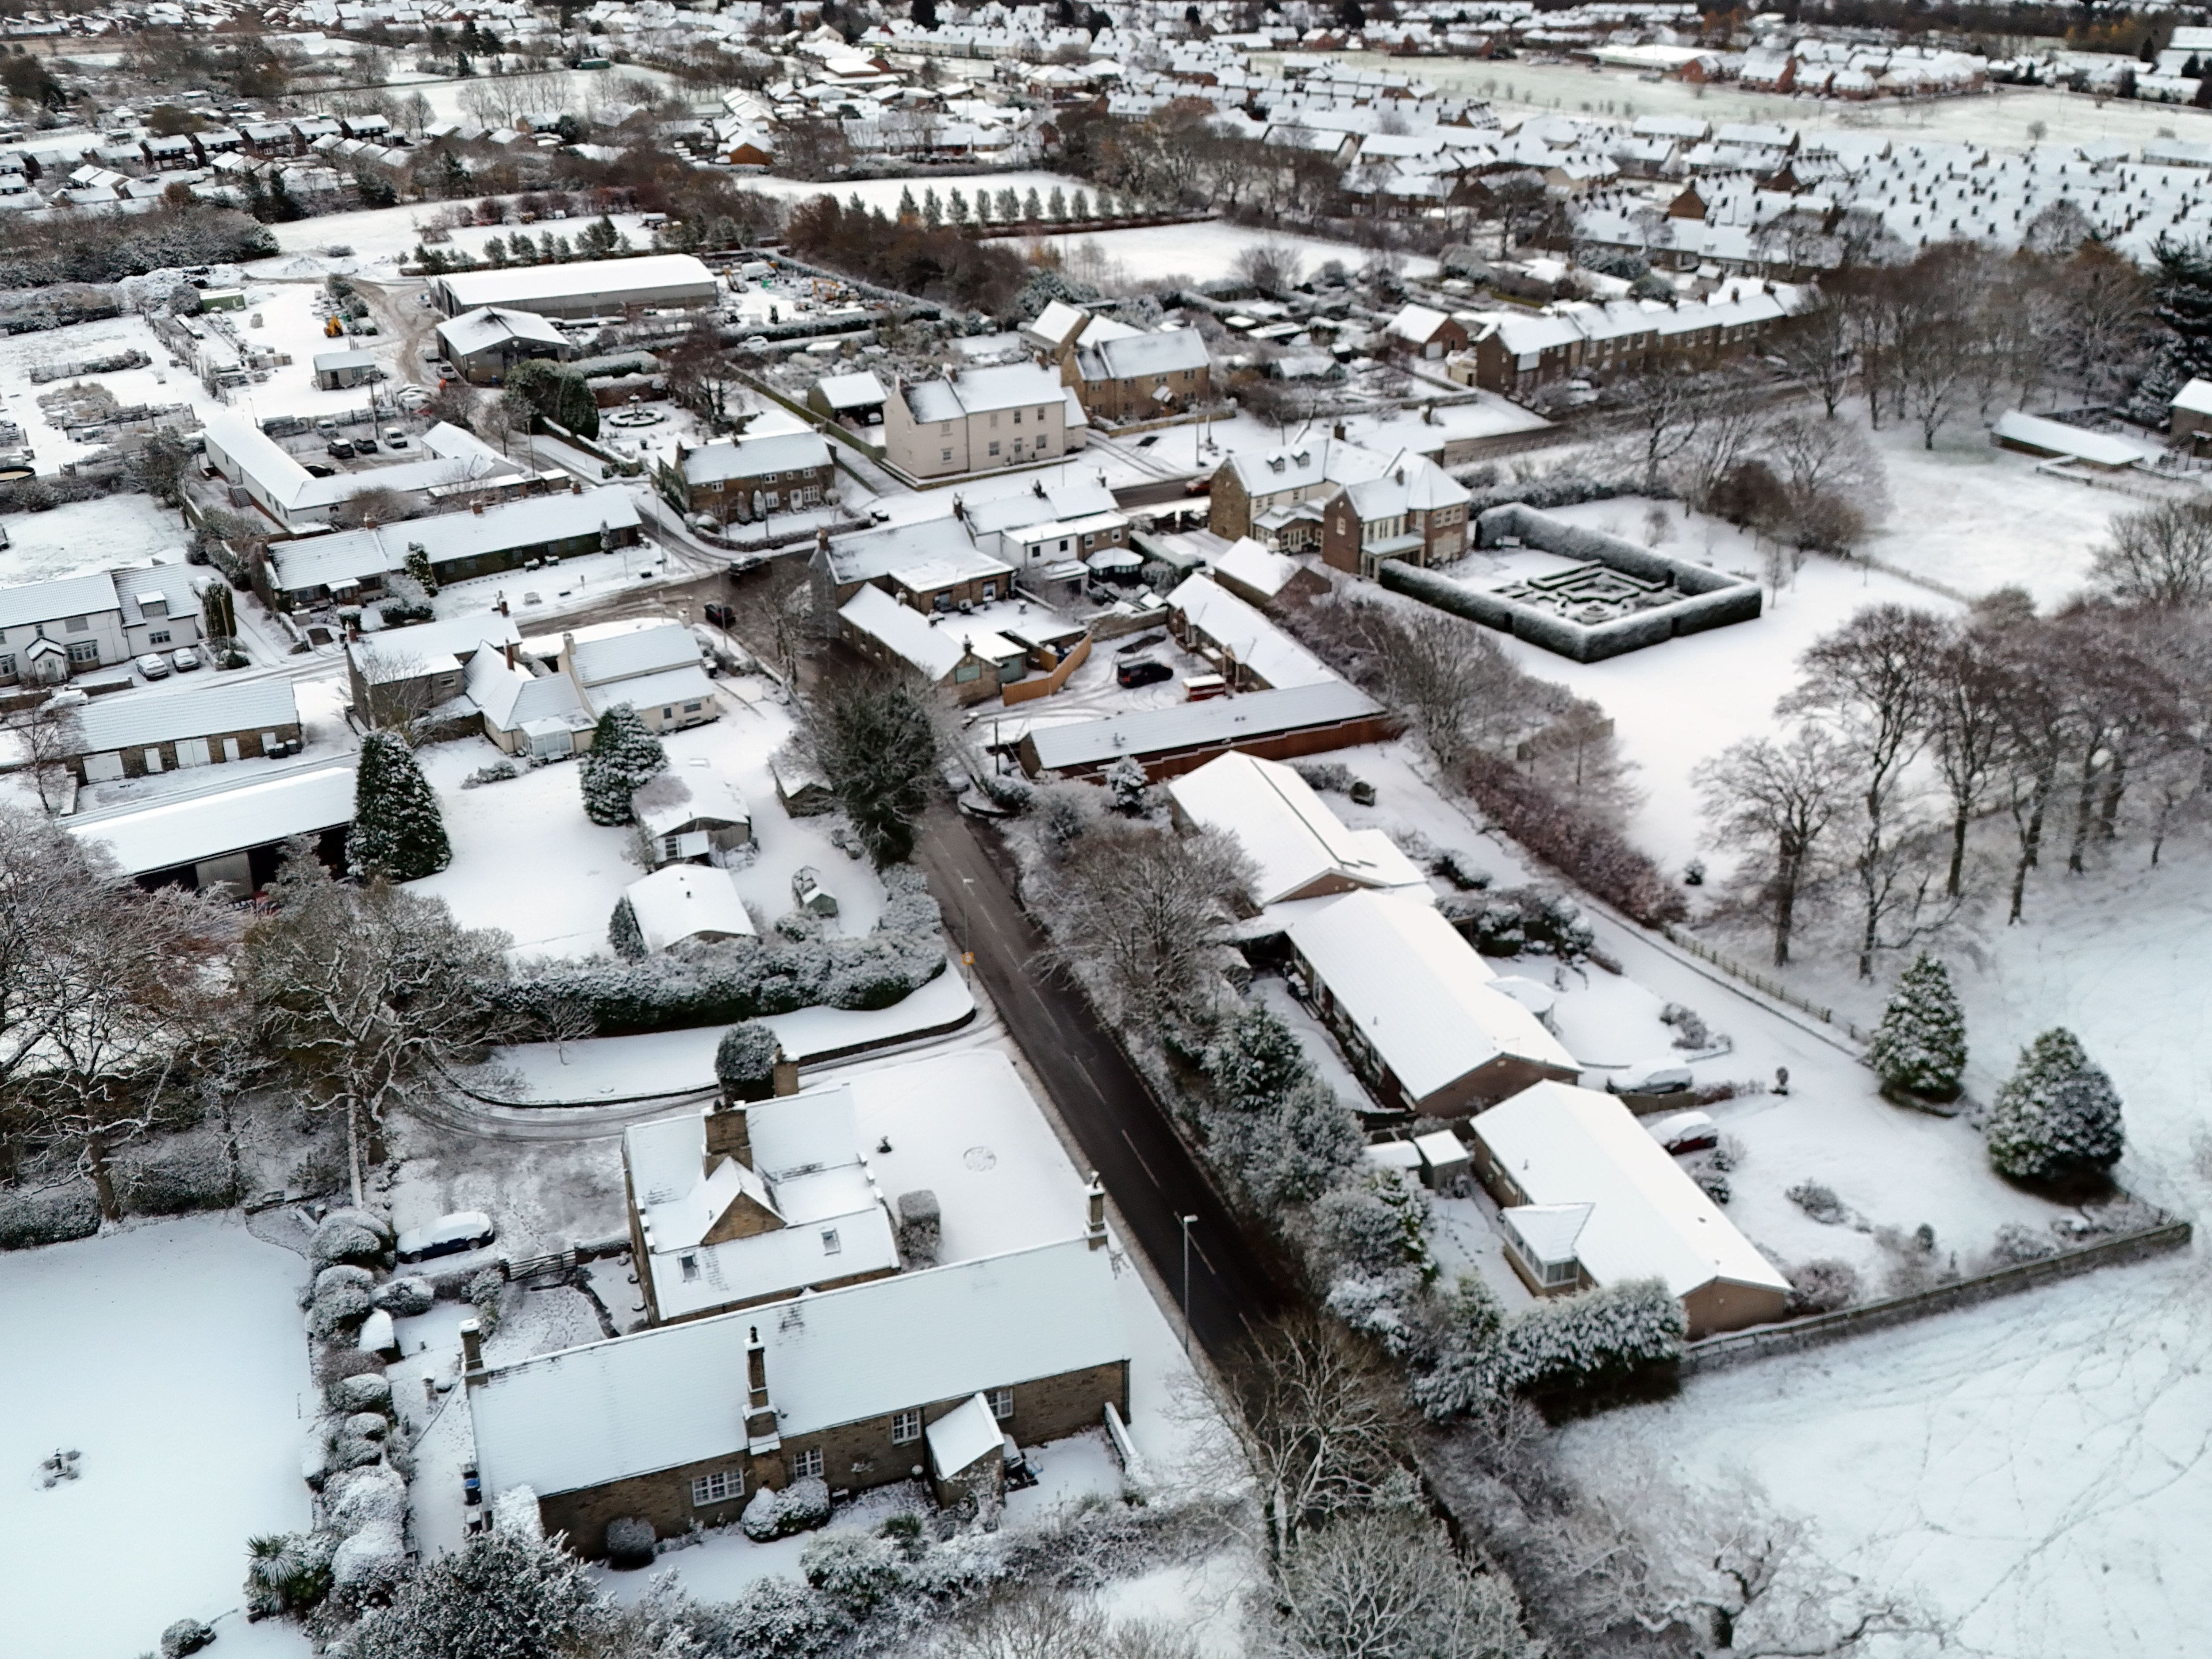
[1283,51,2212,148]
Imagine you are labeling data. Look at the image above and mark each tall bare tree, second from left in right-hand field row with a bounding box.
[1776,604,1944,980]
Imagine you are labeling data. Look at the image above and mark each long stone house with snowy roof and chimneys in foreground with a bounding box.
[462,1228,1128,1555]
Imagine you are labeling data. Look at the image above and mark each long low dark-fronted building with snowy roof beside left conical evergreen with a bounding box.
[66,757,354,896]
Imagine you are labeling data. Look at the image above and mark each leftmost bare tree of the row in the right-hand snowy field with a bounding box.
[1690,726,1851,967]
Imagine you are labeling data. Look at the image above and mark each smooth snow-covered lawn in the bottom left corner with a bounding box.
[0,1214,316,1659]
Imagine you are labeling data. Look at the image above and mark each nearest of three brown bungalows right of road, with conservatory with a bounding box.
[1467,1082,1790,1338]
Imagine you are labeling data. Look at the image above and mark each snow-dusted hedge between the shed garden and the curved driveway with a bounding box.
[507,865,945,1037]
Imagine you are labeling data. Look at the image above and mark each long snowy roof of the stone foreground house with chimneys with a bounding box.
[469,1237,1128,1495]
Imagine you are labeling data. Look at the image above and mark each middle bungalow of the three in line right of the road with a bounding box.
[1290,891,1582,1117]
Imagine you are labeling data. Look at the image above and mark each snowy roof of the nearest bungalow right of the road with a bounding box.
[1469,1082,1790,1296]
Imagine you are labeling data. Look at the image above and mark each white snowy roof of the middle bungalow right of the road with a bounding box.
[1290,891,1579,1099]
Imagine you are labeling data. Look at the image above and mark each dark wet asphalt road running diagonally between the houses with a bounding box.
[916,807,1294,1363]
